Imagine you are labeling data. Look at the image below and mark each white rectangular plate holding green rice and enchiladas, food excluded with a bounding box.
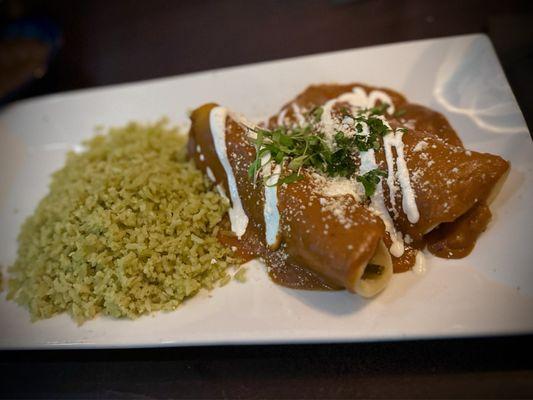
[0,35,533,348]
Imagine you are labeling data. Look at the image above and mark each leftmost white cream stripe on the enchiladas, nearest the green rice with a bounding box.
[209,107,248,238]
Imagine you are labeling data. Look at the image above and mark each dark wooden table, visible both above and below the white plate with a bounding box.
[0,0,533,398]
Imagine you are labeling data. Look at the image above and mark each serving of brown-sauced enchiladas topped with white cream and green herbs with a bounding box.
[188,84,509,297]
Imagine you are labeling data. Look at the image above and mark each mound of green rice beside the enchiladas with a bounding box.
[8,121,238,323]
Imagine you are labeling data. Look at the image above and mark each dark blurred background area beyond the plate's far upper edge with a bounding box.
[0,0,533,127]
